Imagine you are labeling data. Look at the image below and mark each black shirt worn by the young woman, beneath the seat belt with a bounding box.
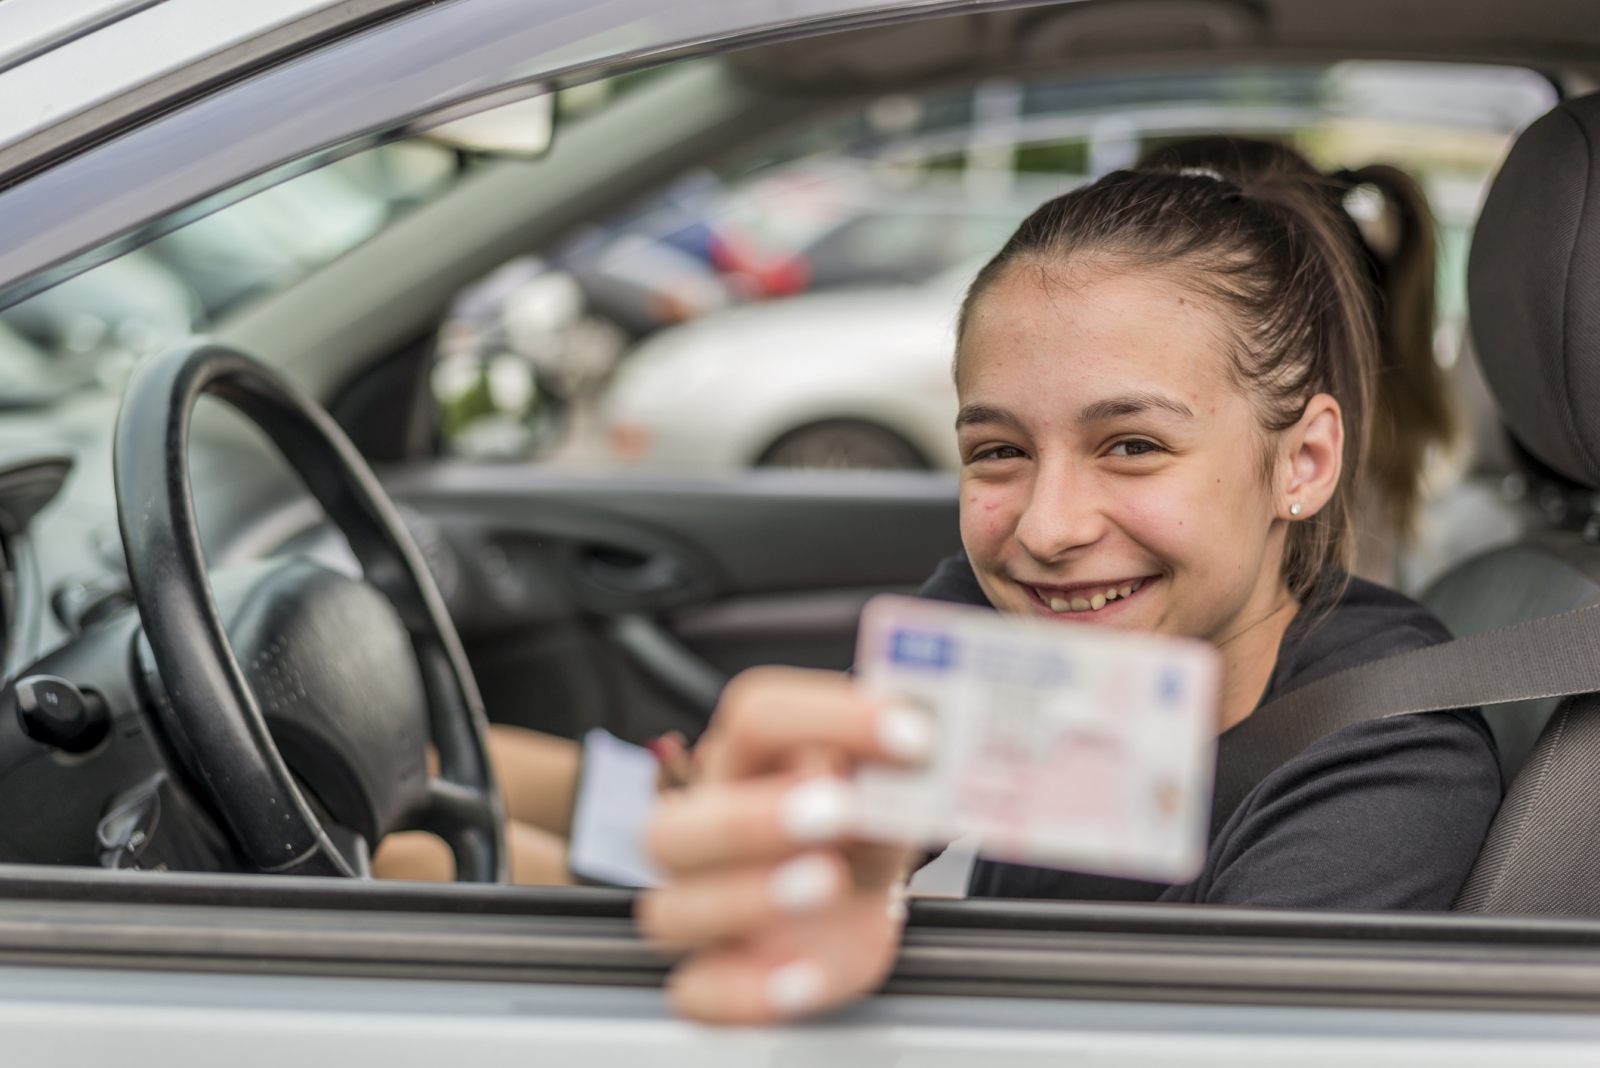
[918,556,1502,910]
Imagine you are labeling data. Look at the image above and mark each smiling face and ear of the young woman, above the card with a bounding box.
[957,264,1342,656]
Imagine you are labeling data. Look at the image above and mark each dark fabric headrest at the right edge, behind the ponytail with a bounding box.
[1467,93,1600,489]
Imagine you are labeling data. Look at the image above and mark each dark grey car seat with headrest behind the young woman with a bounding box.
[1422,87,1600,915]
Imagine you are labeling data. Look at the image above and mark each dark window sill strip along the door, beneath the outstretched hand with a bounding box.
[0,865,1600,1016]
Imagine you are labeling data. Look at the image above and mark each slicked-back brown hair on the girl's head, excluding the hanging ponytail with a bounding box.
[957,142,1378,598]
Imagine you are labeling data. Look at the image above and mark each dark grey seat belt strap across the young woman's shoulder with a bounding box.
[1211,604,1600,841]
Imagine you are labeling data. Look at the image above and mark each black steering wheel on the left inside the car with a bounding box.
[114,341,509,883]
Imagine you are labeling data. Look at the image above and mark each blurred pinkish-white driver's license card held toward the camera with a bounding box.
[856,595,1221,883]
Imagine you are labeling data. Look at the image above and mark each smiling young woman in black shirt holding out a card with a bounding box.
[638,146,1501,1022]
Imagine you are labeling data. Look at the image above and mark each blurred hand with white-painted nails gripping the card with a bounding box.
[637,668,934,1023]
